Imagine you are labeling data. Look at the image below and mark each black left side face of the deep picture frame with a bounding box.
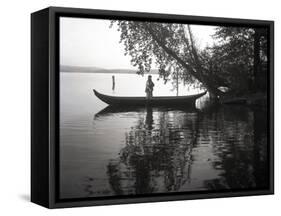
[31,8,50,207]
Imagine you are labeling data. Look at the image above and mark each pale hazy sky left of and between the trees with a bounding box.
[60,17,217,69]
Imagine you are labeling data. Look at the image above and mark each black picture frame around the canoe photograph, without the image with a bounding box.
[31,7,274,208]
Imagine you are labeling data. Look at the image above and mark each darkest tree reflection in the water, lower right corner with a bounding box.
[200,106,269,190]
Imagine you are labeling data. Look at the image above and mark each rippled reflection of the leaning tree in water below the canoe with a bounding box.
[105,107,198,194]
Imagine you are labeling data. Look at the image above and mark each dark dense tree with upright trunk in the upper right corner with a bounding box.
[212,27,267,92]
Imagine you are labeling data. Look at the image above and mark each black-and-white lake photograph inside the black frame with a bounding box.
[58,16,270,199]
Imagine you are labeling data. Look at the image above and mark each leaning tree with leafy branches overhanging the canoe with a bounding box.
[112,20,222,95]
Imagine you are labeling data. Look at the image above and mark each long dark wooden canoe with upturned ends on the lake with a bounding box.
[93,89,207,106]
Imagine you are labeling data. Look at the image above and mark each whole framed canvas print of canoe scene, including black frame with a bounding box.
[31,7,274,208]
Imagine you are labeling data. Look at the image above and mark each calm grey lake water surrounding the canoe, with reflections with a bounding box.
[60,72,268,198]
